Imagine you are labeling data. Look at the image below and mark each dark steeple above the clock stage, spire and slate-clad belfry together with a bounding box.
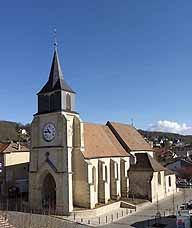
[37,46,75,114]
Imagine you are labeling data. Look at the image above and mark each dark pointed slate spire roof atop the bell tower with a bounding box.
[38,49,75,95]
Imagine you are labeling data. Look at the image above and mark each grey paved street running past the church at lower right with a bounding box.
[99,189,192,228]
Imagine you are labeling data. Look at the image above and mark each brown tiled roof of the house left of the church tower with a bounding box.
[0,143,29,153]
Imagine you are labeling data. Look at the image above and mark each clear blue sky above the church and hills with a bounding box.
[0,0,192,134]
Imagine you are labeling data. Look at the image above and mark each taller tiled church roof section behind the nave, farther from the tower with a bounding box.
[107,122,153,151]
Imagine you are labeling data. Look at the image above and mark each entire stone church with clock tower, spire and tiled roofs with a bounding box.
[29,47,176,215]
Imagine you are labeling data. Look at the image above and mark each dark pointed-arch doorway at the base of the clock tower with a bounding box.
[42,174,56,210]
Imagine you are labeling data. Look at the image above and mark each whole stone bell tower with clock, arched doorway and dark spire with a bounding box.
[29,47,81,215]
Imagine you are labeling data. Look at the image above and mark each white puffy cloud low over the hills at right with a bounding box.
[148,120,192,135]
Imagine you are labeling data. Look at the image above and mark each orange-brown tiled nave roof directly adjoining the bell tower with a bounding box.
[83,123,129,158]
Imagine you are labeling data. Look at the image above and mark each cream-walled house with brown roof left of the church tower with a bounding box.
[0,142,30,196]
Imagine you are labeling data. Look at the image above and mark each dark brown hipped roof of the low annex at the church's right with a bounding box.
[130,153,167,172]
